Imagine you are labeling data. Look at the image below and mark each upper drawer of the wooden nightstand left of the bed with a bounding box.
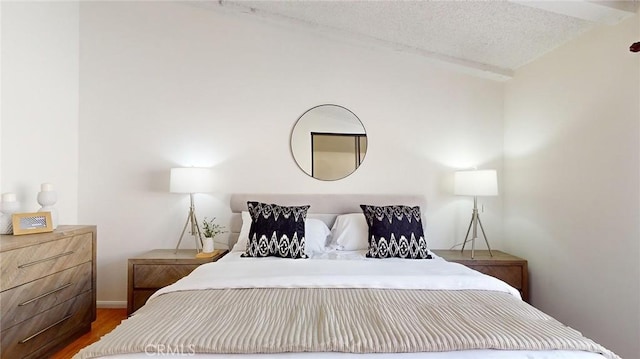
[133,264,200,288]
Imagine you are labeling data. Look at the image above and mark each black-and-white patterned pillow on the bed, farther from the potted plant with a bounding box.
[360,204,432,259]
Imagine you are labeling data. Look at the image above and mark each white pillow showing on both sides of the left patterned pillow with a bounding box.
[232,211,330,255]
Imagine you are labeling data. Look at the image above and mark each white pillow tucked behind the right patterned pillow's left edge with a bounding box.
[331,213,369,251]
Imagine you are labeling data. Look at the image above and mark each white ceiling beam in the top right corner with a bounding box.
[509,0,638,25]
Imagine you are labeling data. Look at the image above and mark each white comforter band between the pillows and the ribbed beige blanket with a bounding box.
[151,252,520,298]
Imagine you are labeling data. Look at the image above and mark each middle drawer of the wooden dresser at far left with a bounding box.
[0,262,92,330]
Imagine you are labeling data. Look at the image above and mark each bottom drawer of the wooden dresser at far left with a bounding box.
[1,292,92,359]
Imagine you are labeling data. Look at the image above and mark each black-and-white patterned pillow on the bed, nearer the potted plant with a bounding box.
[241,202,310,258]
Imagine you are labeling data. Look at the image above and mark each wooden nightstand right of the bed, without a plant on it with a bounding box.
[433,250,529,303]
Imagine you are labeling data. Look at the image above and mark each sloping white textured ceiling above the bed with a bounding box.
[211,0,640,80]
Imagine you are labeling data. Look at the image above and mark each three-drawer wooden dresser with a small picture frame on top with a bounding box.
[0,226,97,359]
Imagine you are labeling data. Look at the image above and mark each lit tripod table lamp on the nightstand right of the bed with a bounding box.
[454,170,498,259]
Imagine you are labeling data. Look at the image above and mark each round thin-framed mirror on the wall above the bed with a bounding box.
[291,105,367,181]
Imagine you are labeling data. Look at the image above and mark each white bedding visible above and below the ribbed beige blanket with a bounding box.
[95,251,604,359]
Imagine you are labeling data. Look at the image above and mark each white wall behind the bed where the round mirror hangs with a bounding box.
[79,2,503,302]
